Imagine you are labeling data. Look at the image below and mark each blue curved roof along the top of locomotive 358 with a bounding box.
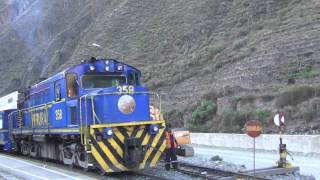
[30,59,141,94]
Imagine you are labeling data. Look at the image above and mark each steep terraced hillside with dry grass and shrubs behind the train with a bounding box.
[0,0,320,131]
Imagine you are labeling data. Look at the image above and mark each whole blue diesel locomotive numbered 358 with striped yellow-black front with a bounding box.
[0,58,166,173]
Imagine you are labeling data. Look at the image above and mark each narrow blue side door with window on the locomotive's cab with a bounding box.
[66,73,79,126]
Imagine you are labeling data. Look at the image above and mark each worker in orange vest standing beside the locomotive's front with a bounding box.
[165,125,178,171]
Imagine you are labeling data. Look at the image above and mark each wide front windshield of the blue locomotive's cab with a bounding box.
[82,75,126,89]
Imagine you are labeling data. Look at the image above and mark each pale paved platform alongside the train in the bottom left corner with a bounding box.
[0,154,93,180]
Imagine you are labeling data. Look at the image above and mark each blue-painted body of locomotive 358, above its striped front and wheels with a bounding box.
[13,59,150,134]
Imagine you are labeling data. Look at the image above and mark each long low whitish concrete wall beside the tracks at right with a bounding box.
[191,133,320,154]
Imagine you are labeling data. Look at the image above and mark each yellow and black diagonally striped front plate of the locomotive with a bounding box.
[90,121,166,172]
